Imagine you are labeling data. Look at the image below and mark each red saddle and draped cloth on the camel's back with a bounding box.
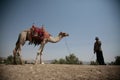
[30,25,50,44]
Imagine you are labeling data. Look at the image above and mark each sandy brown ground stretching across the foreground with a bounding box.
[0,64,120,80]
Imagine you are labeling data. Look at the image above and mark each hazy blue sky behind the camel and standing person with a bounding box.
[0,0,120,62]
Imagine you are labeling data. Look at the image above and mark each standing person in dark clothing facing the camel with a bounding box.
[94,37,105,65]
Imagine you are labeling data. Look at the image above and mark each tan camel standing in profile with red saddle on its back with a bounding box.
[13,25,69,64]
